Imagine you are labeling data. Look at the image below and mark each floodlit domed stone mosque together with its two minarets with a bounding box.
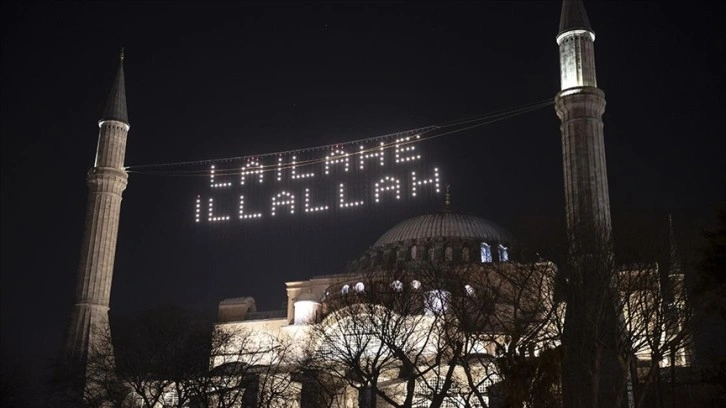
[64,0,688,408]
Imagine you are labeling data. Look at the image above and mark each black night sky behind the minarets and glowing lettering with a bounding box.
[0,1,726,402]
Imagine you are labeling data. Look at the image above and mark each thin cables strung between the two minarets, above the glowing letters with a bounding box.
[125,98,554,177]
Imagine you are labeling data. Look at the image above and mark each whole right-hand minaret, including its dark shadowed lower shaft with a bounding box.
[555,0,626,408]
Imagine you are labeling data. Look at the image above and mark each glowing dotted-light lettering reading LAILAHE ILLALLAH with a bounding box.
[194,134,441,224]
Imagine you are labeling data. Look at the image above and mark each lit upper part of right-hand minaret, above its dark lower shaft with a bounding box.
[555,0,611,249]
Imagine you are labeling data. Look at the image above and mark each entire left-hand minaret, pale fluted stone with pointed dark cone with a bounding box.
[63,50,129,372]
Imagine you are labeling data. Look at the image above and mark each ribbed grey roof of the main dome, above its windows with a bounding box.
[373,211,509,247]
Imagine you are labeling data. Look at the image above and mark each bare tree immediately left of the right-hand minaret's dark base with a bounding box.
[430,261,563,406]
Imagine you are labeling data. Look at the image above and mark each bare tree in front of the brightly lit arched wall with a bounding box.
[310,268,456,407]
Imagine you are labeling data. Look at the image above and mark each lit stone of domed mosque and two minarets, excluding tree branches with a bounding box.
[59,0,687,408]
